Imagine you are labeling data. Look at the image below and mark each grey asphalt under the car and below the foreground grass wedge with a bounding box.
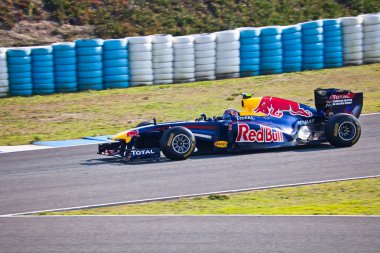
[0,115,380,252]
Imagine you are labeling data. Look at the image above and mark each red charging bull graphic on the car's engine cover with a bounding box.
[253,97,313,118]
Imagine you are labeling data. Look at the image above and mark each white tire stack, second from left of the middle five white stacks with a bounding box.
[152,34,174,84]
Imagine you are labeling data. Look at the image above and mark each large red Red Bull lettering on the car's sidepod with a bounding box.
[236,124,284,142]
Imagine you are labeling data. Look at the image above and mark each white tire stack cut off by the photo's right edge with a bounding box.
[362,13,380,63]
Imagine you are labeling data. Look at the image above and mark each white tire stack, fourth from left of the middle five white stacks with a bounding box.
[194,33,216,81]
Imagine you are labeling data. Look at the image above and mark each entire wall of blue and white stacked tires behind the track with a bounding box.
[0,13,380,97]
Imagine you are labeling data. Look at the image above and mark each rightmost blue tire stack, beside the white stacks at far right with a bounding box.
[323,19,343,68]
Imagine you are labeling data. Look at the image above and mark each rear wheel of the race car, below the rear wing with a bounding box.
[325,113,361,147]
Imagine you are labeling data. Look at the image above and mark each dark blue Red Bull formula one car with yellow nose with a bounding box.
[98,89,363,161]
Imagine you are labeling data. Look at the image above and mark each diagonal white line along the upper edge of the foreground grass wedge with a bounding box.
[0,175,380,217]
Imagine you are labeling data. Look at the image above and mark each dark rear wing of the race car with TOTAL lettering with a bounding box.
[314,88,363,118]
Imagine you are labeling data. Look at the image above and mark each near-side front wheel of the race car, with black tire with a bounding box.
[160,126,196,160]
